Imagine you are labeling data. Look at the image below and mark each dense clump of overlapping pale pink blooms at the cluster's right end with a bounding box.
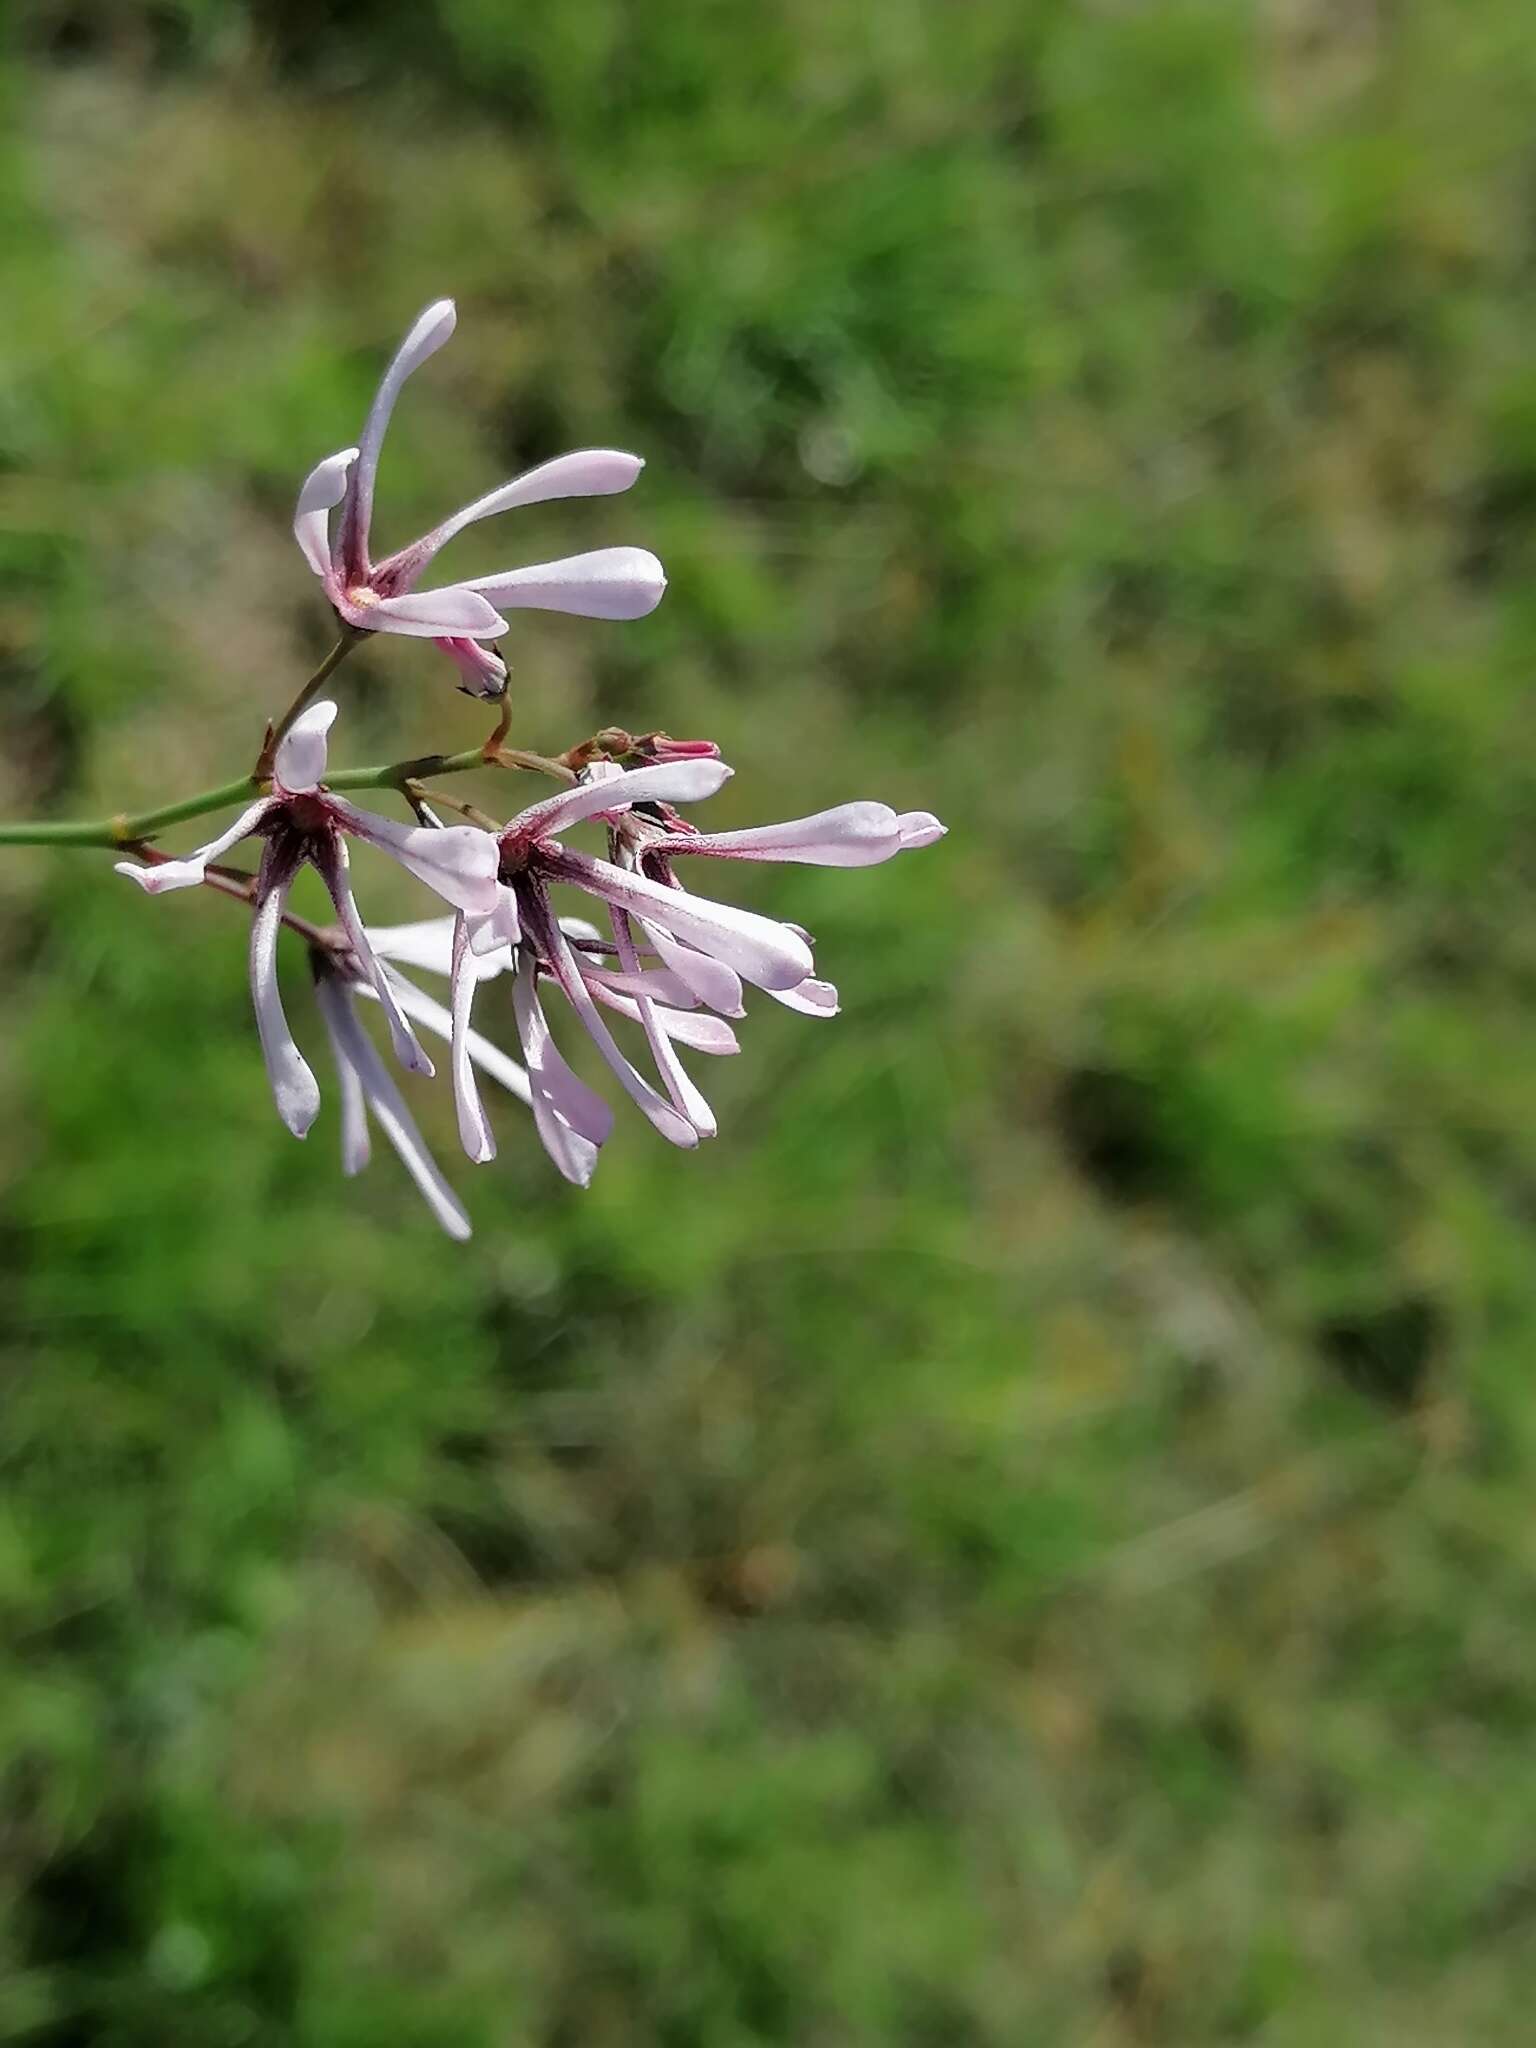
[451,748,944,1180]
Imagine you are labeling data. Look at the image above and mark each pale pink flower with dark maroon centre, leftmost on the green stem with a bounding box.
[117,702,498,1137]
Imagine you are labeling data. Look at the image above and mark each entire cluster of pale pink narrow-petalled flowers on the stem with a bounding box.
[105,299,944,1237]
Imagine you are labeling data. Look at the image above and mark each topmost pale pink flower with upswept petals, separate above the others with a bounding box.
[293,299,666,696]
